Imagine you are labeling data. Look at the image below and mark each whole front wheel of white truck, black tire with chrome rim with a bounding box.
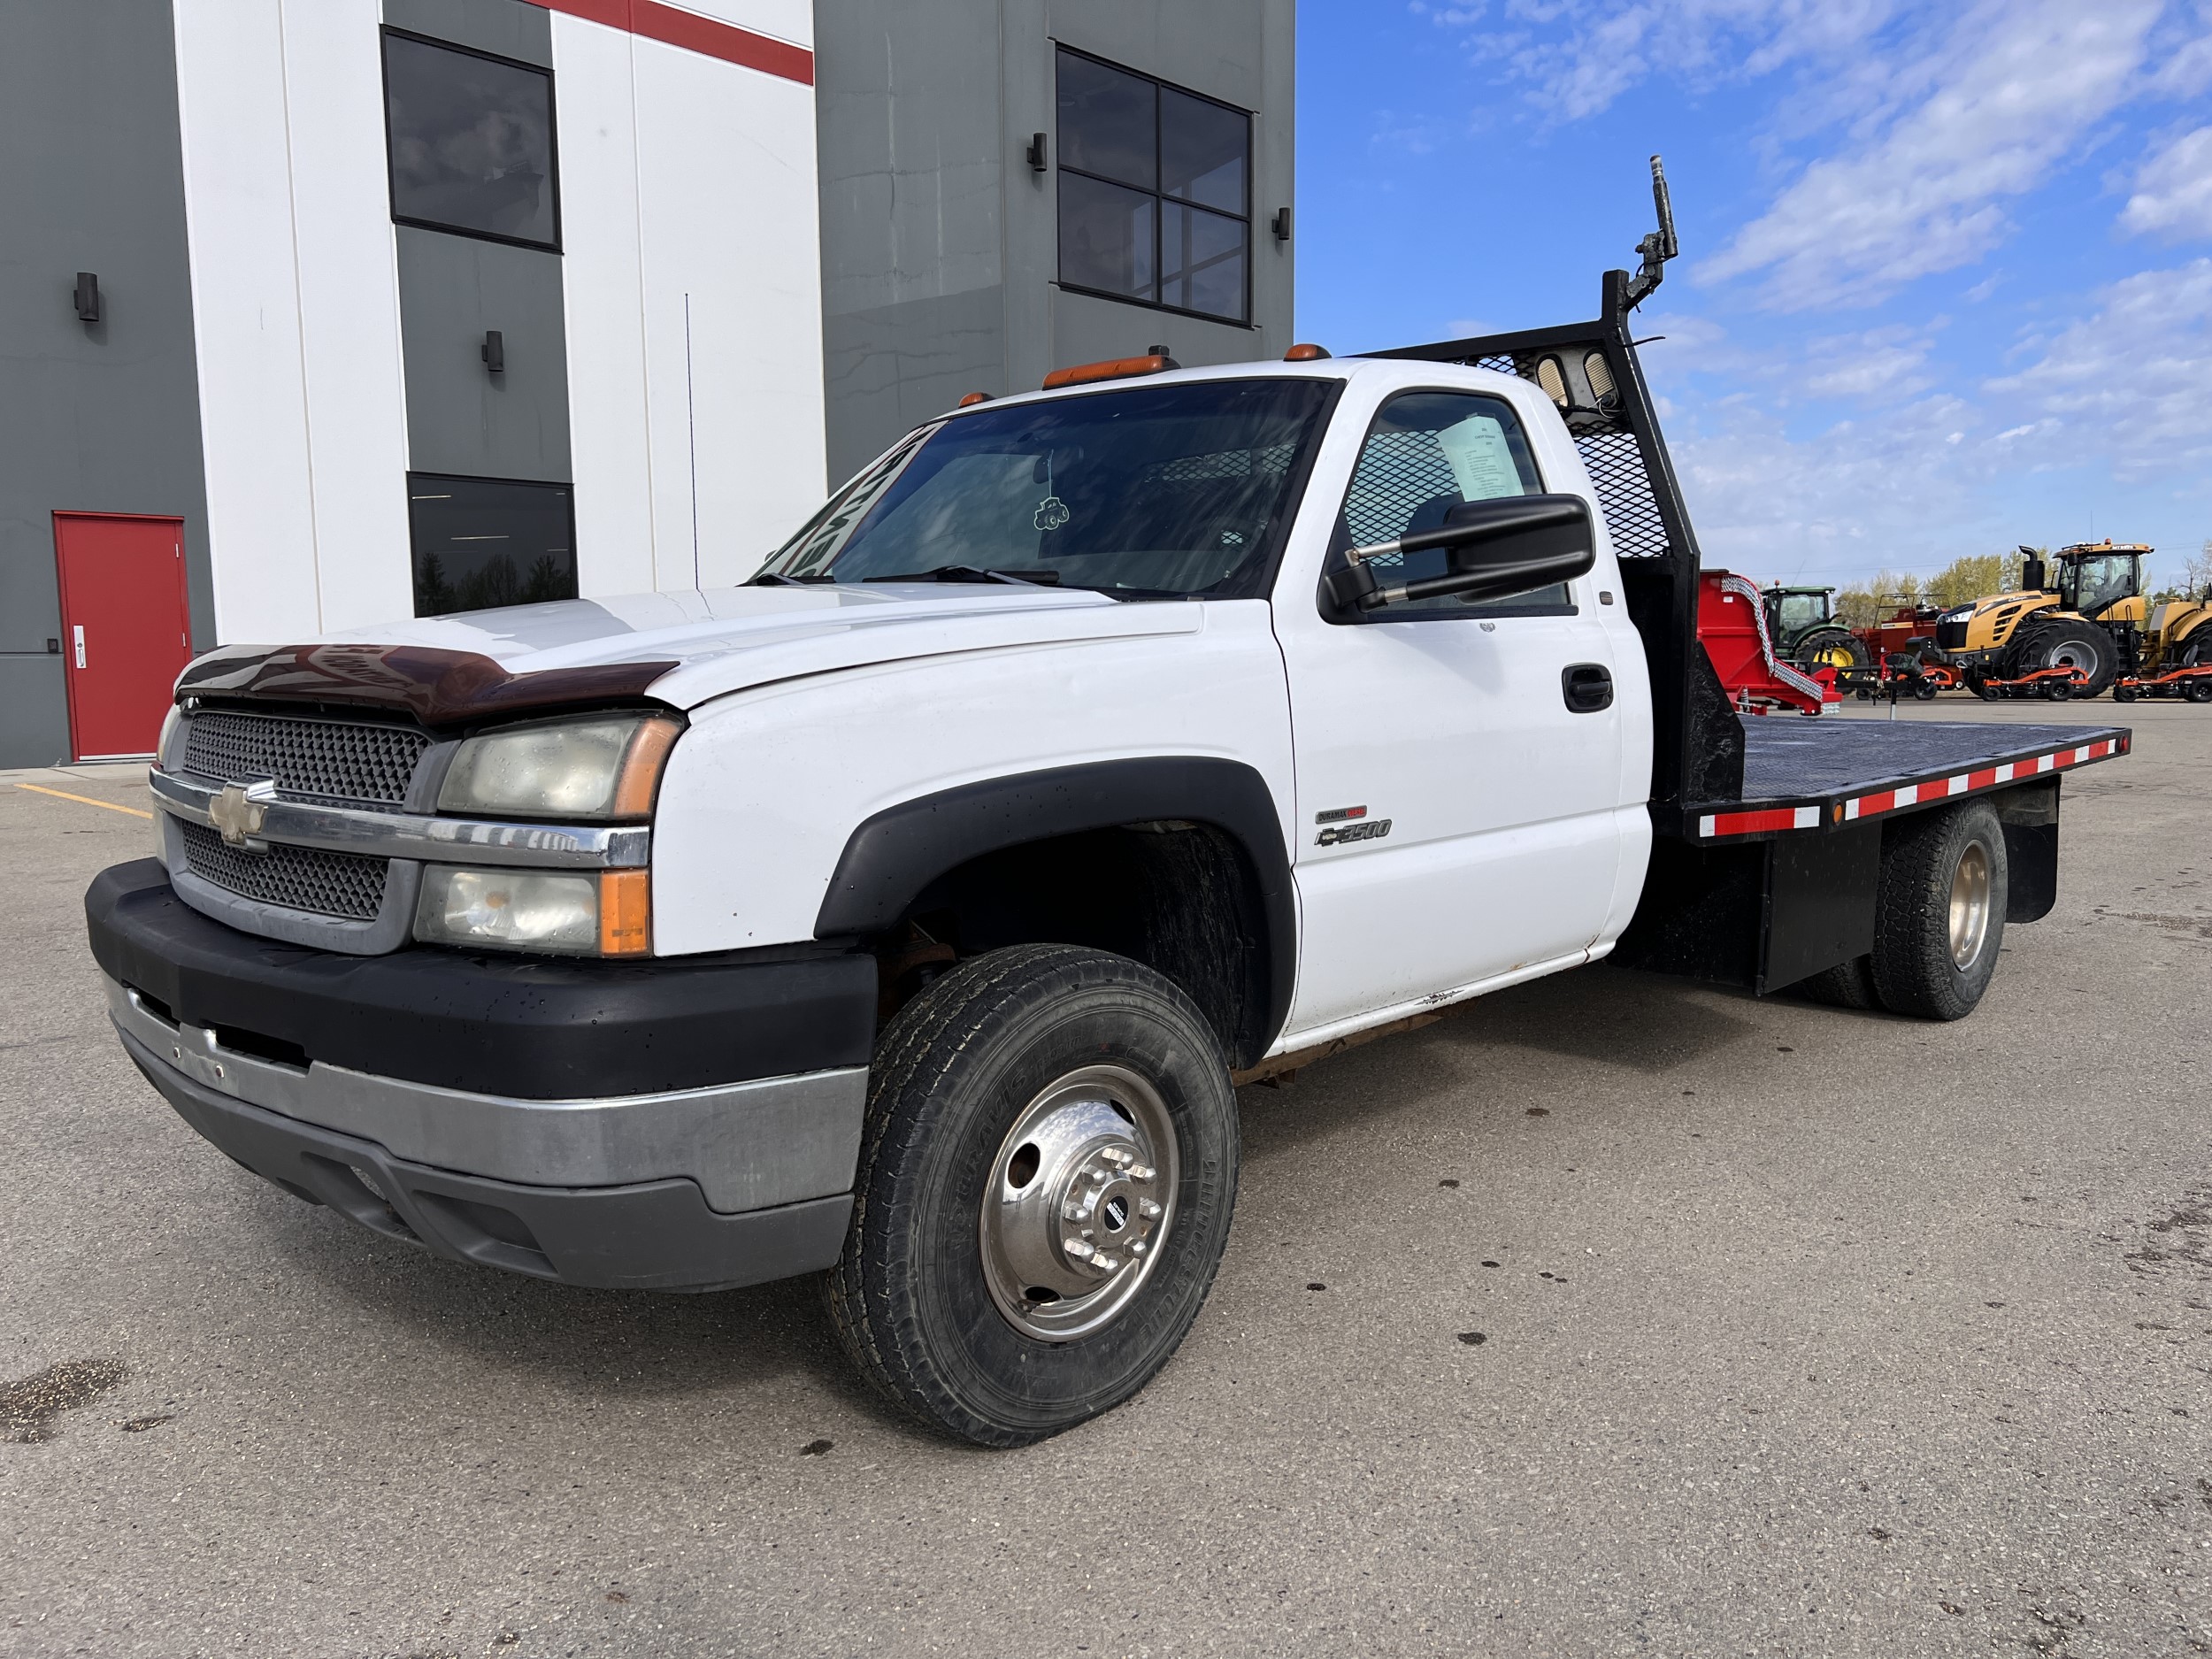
[830,945,1237,1447]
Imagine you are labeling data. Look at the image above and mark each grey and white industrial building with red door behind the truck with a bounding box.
[0,0,1294,765]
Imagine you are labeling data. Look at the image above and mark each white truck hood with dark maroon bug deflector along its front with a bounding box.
[180,582,1206,719]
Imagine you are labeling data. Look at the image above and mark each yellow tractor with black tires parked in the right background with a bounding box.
[1936,542,2212,697]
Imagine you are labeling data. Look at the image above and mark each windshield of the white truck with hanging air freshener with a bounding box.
[761,379,1340,597]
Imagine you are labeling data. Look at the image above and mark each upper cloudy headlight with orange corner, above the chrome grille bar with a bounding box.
[438,715,684,821]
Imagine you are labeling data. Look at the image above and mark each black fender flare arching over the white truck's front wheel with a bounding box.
[814,755,1299,1051]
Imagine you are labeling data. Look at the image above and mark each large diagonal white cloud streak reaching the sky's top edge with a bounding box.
[1699,0,2162,310]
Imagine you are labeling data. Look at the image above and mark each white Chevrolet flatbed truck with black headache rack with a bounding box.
[87,173,2128,1445]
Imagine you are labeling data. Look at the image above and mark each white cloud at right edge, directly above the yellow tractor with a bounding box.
[1985,259,2212,482]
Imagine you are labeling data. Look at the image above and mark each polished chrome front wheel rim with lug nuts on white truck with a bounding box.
[978,1066,1177,1343]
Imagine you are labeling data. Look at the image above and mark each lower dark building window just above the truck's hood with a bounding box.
[407,473,575,618]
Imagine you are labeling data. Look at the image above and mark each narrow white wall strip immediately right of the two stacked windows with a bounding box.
[553,13,655,595]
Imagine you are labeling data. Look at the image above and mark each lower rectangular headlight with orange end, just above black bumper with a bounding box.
[414,865,653,956]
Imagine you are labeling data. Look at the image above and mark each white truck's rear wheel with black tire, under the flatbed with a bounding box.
[1871,801,2007,1020]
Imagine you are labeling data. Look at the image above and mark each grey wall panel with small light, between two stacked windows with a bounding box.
[398,226,573,485]
